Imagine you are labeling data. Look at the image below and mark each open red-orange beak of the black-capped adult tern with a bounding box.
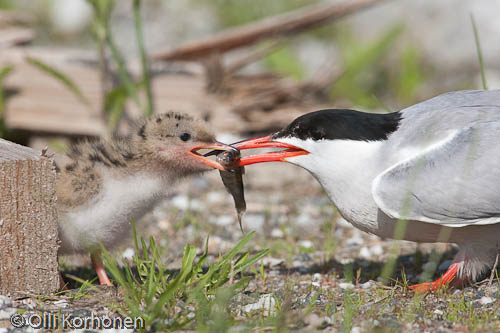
[231,135,309,166]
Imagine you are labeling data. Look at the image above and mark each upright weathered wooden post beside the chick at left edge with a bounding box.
[0,139,59,295]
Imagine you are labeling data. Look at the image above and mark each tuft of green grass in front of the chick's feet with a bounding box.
[102,222,269,331]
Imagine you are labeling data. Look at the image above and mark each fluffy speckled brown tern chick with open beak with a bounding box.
[56,112,231,285]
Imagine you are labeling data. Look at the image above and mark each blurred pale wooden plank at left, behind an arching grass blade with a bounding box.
[0,48,106,136]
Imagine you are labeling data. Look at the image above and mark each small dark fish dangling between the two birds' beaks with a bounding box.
[207,148,247,234]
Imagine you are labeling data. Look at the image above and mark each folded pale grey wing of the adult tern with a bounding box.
[372,121,500,227]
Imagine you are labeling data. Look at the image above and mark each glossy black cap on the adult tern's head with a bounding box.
[272,109,401,141]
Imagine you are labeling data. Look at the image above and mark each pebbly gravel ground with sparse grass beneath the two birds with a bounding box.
[0,164,500,333]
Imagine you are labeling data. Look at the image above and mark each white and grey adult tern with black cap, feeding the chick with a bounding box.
[234,90,500,292]
